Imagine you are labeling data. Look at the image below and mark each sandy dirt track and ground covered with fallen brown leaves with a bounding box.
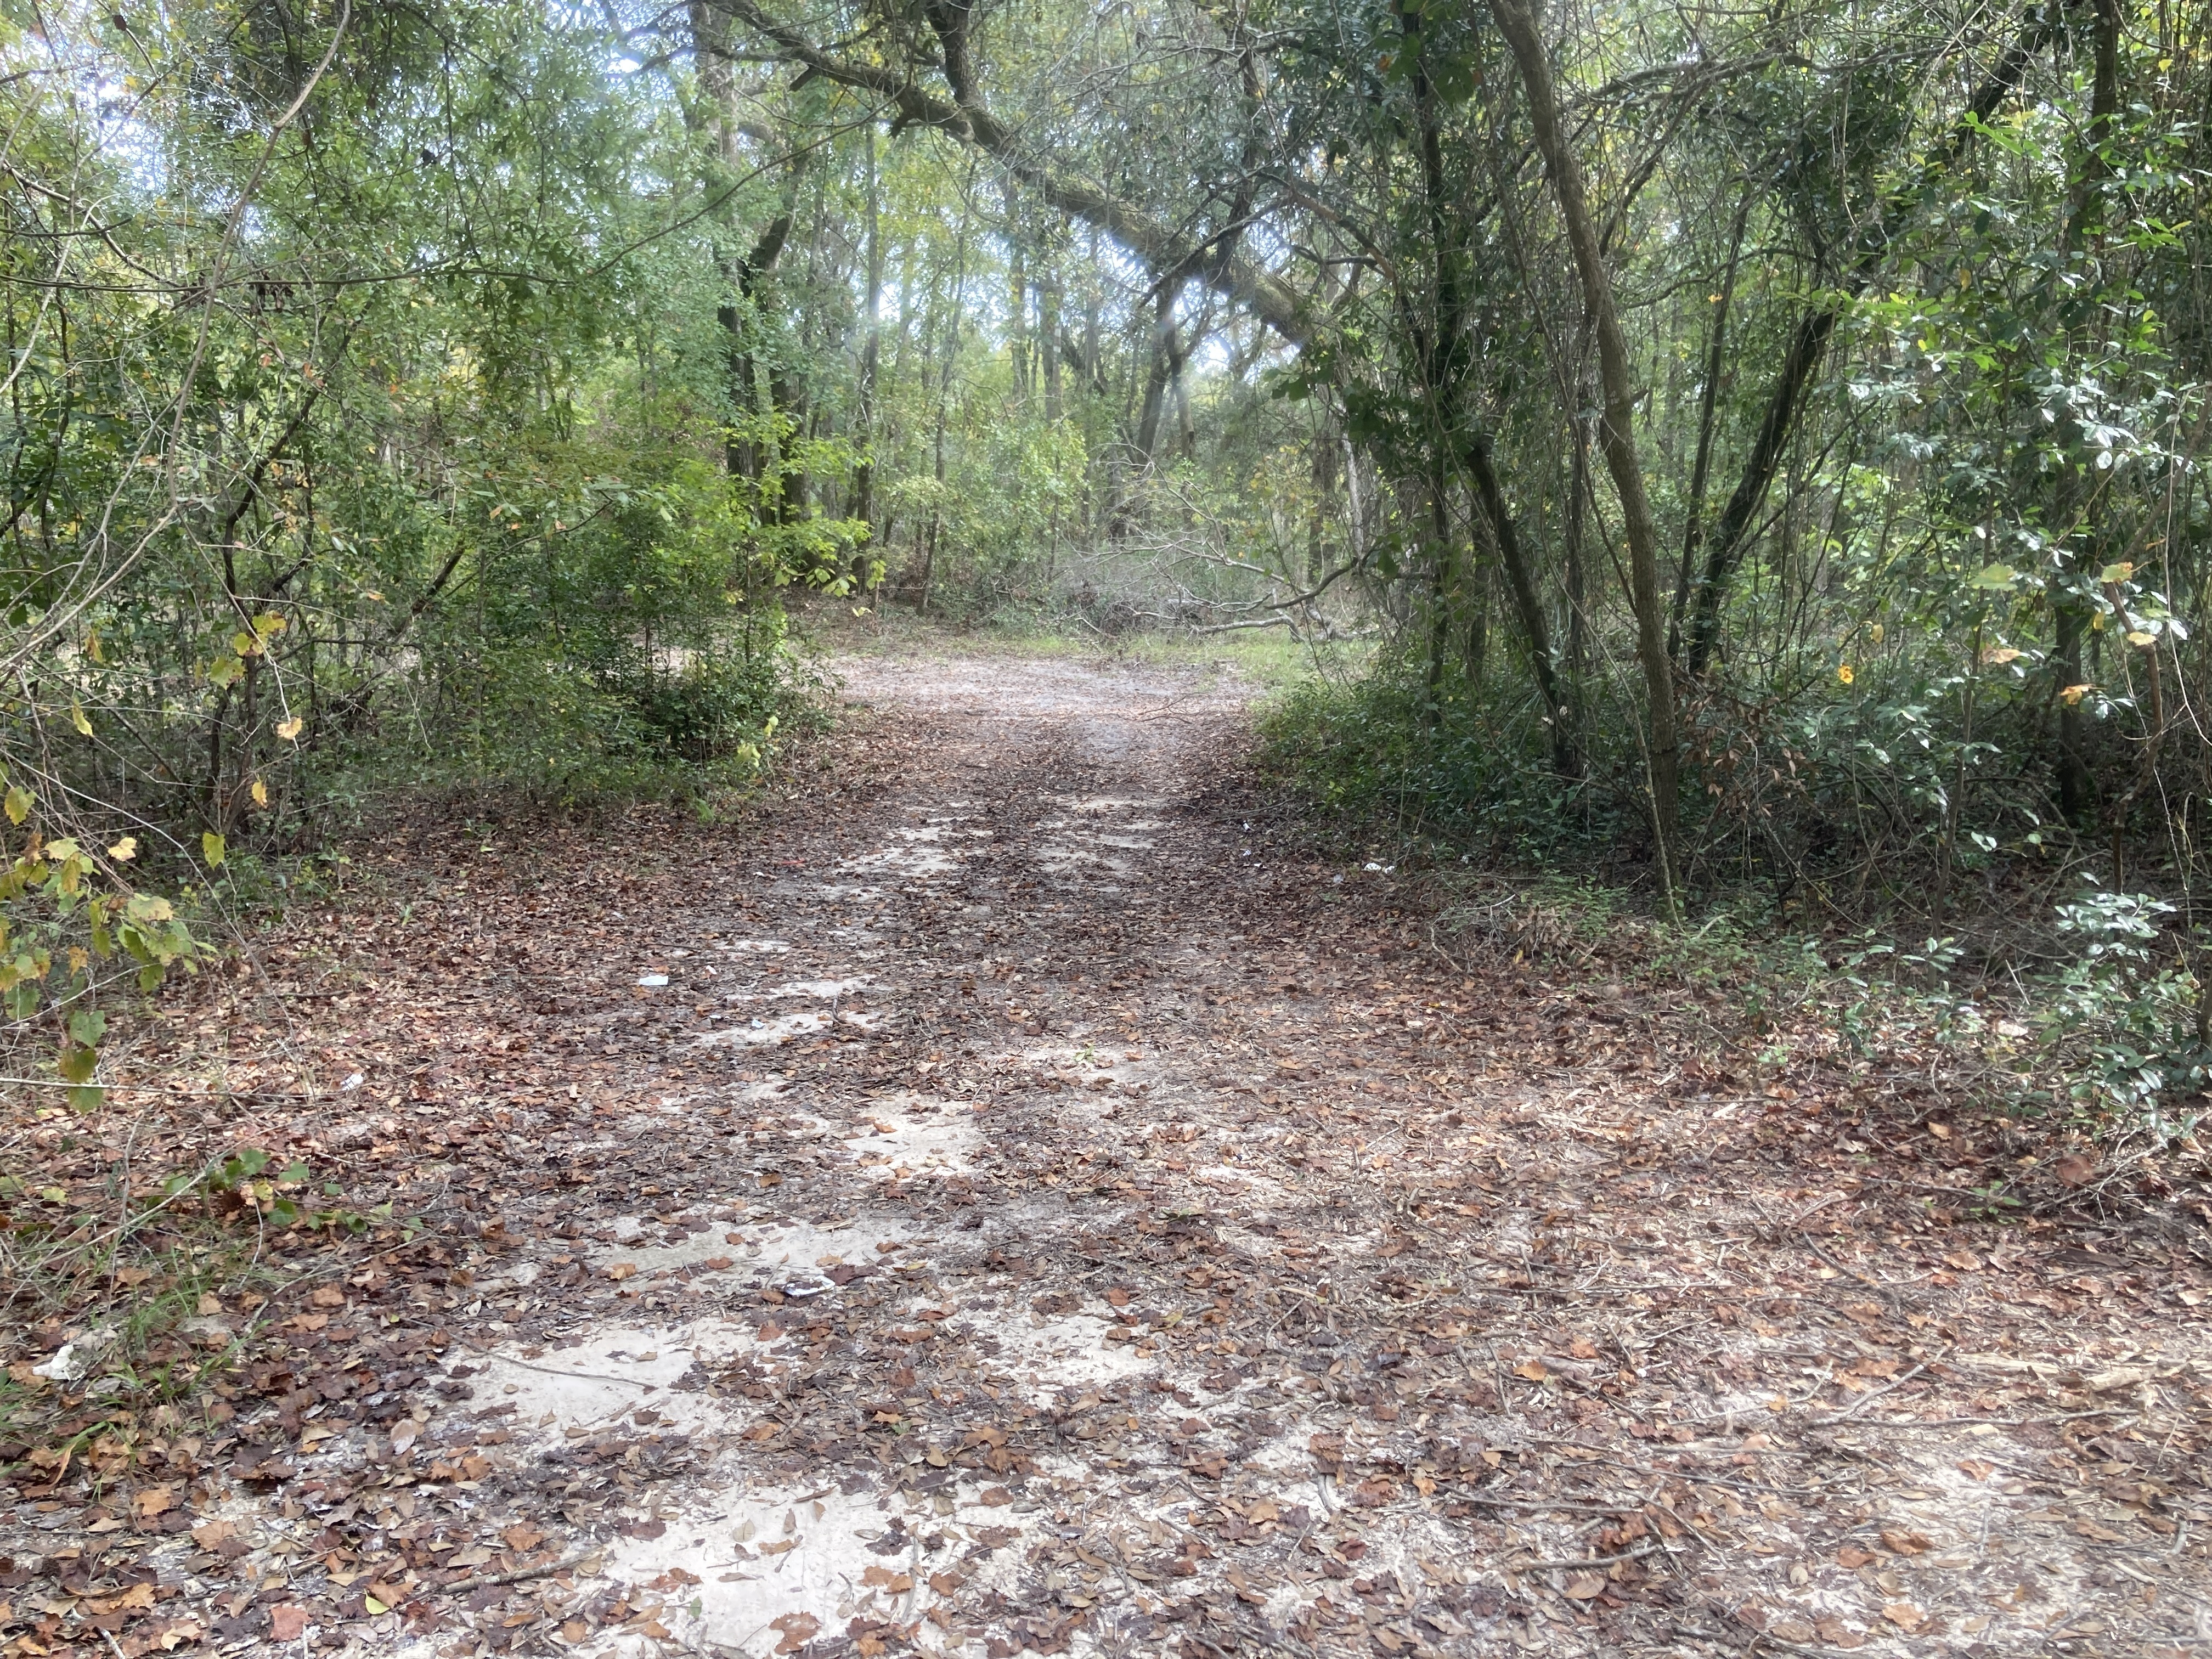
[0,654,2212,1659]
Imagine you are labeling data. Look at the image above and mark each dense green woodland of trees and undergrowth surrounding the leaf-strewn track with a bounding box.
[0,0,2212,1119]
